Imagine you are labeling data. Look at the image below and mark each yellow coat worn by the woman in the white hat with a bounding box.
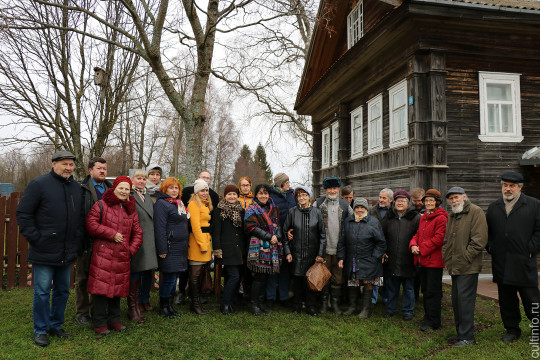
[188,199,211,262]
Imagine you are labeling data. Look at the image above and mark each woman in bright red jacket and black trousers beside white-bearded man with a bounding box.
[409,189,448,331]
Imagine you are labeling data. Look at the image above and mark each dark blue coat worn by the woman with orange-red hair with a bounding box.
[154,192,189,272]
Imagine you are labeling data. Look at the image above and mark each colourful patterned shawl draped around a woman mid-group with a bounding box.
[244,198,283,274]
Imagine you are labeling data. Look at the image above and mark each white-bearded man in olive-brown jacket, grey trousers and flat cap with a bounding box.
[443,186,488,347]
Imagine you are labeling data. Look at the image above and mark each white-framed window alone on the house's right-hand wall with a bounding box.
[478,71,523,142]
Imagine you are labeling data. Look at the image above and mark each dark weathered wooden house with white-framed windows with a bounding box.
[295,0,540,209]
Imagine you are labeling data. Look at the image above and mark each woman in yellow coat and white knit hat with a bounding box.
[188,179,212,315]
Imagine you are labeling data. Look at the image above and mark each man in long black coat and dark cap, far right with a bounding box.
[486,172,540,343]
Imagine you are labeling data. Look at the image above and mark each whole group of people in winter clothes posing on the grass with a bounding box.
[17,151,540,347]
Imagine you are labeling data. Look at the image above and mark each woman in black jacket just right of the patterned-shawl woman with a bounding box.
[283,186,326,316]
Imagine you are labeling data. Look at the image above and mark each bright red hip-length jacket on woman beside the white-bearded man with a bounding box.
[409,208,448,268]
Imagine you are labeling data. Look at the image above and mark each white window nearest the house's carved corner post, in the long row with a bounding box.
[388,80,409,148]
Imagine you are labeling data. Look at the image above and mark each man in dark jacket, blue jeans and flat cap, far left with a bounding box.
[17,151,81,346]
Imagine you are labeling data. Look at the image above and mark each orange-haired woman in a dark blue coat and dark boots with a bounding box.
[154,177,189,319]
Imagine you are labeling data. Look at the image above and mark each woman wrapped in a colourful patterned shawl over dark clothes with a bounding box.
[244,184,283,315]
